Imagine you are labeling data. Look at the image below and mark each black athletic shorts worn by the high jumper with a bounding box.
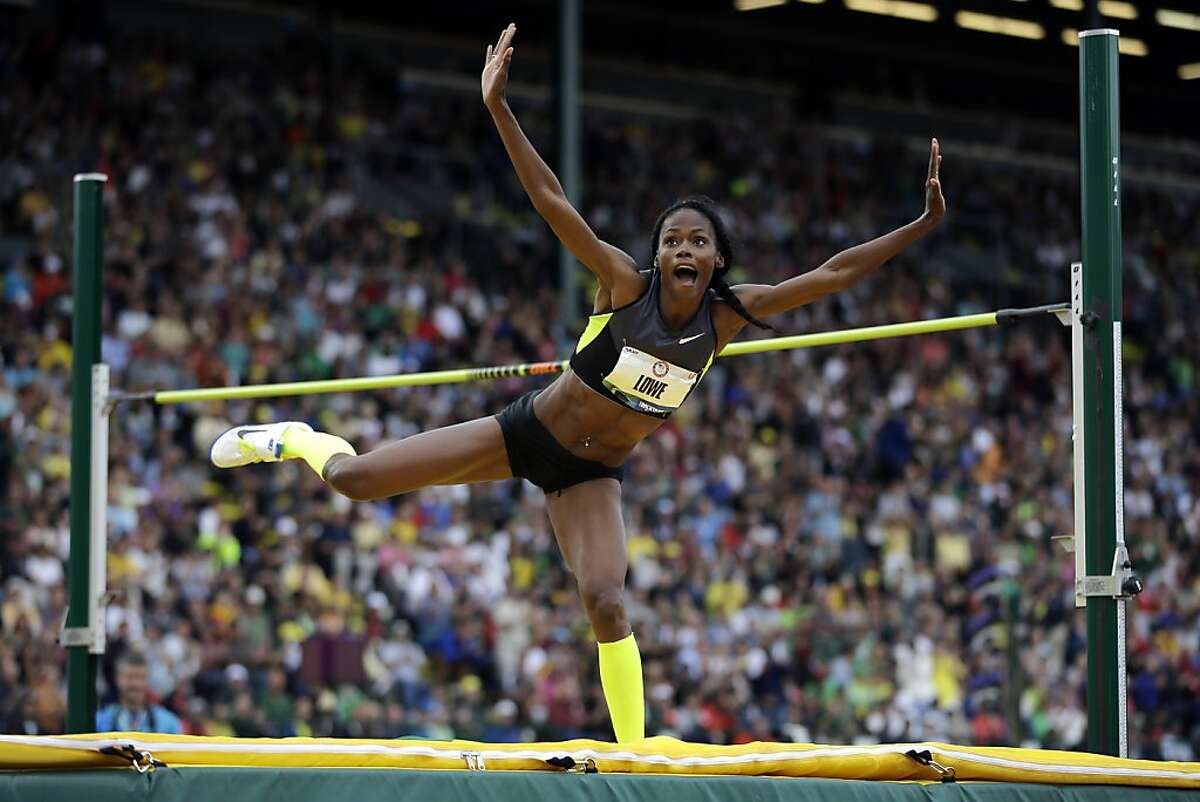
[496,390,625,493]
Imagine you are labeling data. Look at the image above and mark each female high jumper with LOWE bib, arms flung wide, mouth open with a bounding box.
[211,25,946,742]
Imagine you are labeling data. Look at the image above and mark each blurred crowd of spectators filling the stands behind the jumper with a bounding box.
[0,29,1200,760]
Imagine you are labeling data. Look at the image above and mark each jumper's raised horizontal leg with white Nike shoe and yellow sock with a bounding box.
[212,417,512,501]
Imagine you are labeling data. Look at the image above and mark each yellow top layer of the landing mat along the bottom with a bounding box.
[0,732,1200,789]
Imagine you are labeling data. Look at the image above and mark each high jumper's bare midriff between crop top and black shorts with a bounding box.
[533,367,666,467]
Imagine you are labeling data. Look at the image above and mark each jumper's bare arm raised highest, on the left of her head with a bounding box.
[481,24,640,294]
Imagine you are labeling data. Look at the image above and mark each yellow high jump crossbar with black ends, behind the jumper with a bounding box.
[109,304,1070,403]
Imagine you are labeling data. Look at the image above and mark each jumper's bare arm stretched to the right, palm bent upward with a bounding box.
[733,139,946,317]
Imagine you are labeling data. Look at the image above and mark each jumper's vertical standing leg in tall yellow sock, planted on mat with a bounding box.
[546,479,646,743]
